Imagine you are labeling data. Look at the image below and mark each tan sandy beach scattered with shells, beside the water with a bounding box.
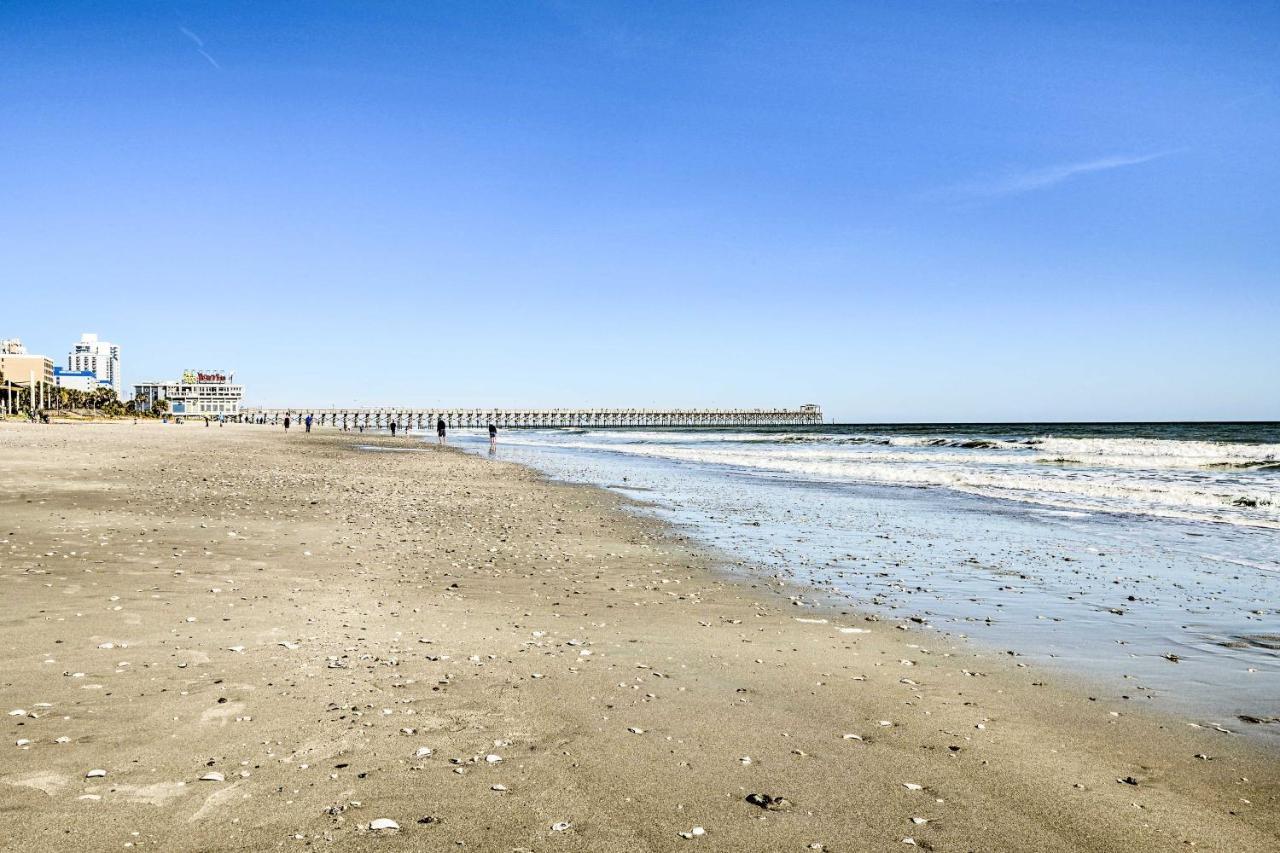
[0,423,1280,850]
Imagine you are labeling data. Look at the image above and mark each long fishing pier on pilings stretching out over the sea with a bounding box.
[241,403,822,429]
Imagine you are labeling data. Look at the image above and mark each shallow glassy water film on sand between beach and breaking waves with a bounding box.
[442,430,1280,736]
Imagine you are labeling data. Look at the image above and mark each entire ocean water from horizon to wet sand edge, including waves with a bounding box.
[454,423,1280,736]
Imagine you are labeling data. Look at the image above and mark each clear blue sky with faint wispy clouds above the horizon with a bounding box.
[0,0,1280,420]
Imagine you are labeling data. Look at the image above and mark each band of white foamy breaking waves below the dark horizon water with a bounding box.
[496,430,1280,528]
